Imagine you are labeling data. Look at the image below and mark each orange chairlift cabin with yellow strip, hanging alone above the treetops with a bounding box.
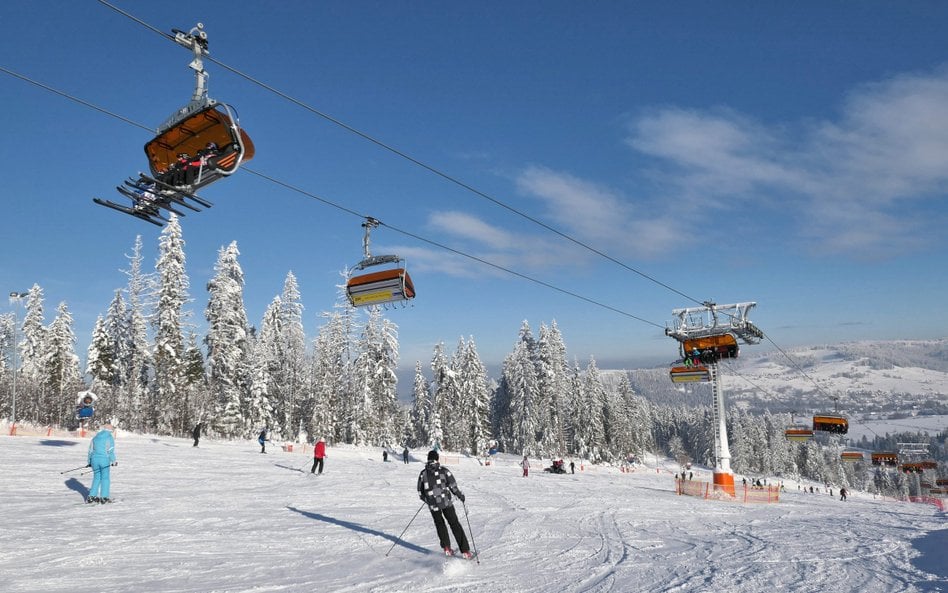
[346,217,415,307]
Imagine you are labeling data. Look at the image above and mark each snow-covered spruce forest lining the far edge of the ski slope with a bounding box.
[0,220,948,496]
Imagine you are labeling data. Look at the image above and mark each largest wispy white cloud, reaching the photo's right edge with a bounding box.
[627,71,948,256]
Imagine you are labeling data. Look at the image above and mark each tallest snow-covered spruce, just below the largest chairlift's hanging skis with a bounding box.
[148,214,190,434]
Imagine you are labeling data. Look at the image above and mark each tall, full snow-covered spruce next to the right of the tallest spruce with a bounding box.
[204,241,252,438]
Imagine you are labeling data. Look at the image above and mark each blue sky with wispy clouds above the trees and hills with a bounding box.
[0,0,948,367]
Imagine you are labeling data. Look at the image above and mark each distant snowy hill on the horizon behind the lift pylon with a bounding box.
[603,339,948,416]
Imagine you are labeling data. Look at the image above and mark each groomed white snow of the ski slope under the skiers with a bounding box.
[0,434,948,593]
